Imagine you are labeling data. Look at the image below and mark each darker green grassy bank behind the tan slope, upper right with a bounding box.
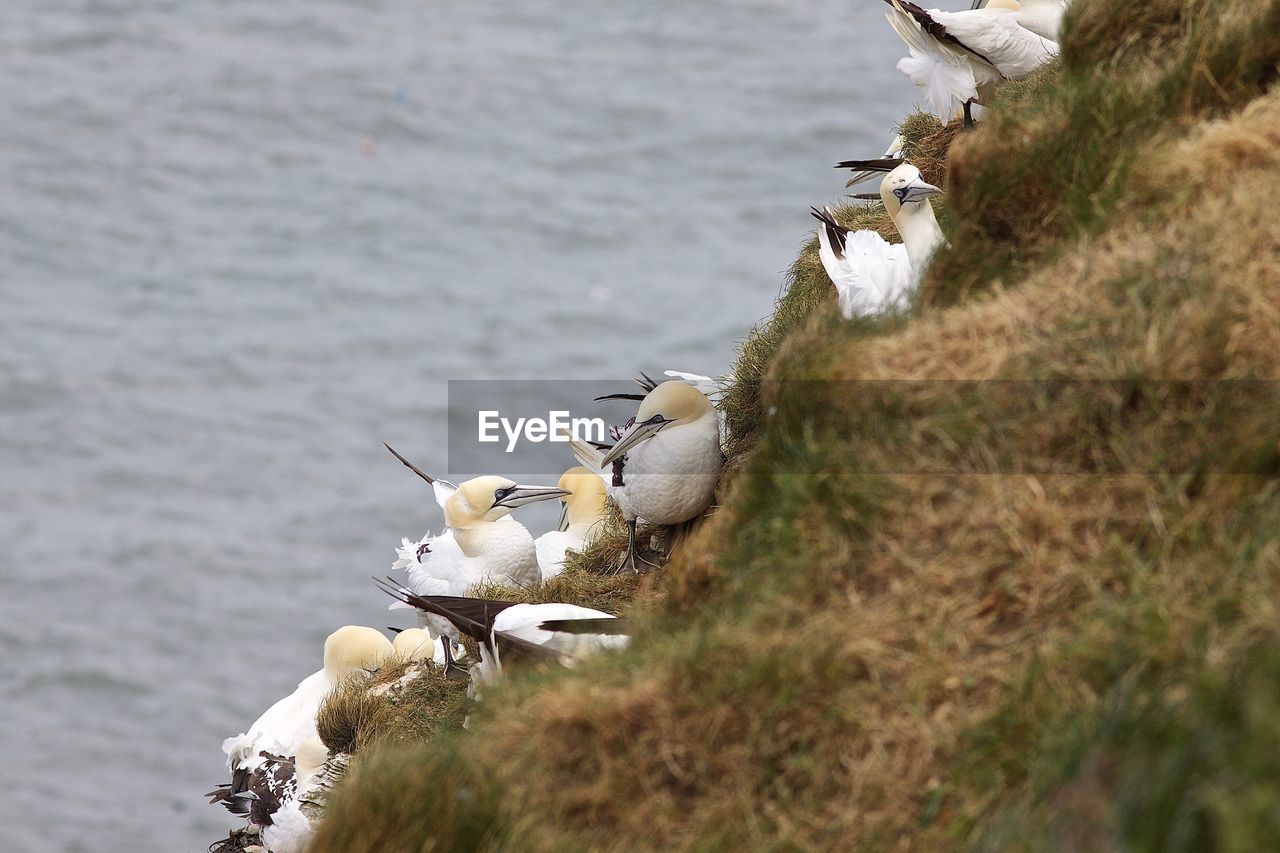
[922,0,1280,305]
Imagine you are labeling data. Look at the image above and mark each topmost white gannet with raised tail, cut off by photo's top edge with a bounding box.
[884,0,1057,127]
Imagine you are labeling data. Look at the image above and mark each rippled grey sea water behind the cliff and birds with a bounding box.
[0,0,921,850]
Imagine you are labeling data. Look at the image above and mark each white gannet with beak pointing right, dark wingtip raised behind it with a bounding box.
[387,447,568,625]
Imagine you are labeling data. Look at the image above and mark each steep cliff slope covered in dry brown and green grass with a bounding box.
[307,0,1280,850]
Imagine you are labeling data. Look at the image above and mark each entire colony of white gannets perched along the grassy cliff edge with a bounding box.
[209,0,1068,853]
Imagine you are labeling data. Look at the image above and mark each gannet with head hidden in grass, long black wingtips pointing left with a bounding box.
[379,581,630,685]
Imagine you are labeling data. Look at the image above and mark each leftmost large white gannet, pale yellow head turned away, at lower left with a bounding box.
[209,625,392,808]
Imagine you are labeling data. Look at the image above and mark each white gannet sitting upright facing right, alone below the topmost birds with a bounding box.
[813,163,945,319]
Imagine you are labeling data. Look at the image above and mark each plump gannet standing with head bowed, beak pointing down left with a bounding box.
[571,379,724,571]
